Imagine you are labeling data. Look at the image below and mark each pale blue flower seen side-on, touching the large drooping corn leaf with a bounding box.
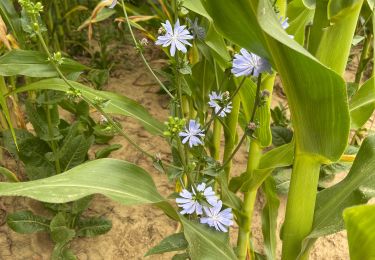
[232,48,271,77]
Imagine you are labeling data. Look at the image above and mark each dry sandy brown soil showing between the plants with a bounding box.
[0,46,349,260]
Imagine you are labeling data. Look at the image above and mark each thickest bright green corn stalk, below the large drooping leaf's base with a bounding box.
[281,154,321,260]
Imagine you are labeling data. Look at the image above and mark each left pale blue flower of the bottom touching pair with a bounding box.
[176,183,218,215]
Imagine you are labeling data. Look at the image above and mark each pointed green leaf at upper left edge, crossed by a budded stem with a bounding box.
[0,50,88,78]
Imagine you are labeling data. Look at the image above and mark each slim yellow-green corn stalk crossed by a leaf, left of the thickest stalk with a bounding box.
[237,140,262,260]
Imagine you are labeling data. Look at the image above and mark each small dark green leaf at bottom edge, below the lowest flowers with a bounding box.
[145,233,188,256]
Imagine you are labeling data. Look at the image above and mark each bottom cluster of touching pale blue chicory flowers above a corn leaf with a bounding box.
[176,183,233,232]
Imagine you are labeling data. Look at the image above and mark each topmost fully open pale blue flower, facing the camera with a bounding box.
[155,20,193,56]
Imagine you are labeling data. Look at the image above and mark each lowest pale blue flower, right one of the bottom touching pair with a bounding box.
[200,200,233,232]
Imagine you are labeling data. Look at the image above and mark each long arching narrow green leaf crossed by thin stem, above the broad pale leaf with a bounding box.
[10,79,164,134]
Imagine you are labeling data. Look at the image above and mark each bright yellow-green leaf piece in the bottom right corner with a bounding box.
[344,205,375,260]
